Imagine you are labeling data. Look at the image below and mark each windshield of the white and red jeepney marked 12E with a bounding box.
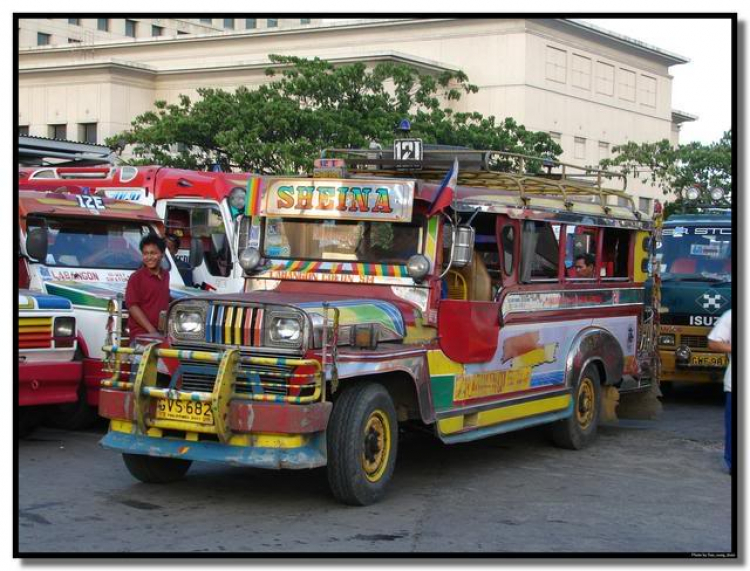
[29,218,150,270]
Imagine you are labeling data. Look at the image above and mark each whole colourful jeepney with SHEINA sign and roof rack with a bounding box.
[100,151,655,505]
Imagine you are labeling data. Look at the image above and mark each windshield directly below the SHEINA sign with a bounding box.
[263,218,422,264]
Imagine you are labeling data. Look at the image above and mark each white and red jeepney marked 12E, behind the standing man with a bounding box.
[18,190,197,428]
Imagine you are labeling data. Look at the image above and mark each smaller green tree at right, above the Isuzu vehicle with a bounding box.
[600,130,732,214]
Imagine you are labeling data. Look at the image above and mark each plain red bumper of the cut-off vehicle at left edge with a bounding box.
[18,361,83,406]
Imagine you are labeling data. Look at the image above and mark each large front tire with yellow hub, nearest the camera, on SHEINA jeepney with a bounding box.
[327,383,398,506]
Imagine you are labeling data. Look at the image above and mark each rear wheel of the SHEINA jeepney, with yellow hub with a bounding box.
[552,365,602,450]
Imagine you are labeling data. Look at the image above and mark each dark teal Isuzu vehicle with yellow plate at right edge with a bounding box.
[657,210,732,388]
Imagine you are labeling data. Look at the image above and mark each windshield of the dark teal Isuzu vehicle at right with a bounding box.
[658,226,732,279]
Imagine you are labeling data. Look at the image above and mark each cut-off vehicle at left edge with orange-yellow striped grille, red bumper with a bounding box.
[17,290,81,436]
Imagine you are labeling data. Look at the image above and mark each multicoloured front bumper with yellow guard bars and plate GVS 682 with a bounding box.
[99,344,332,469]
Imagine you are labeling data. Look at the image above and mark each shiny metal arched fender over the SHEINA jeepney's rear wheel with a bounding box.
[565,327,625,387]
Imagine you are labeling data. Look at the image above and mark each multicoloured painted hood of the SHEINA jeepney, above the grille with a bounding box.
[197,291,406,340]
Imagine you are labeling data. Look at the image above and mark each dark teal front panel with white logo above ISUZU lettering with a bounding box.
[661,279,732,325]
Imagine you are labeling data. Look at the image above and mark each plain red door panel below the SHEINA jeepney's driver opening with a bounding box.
[438,299,500,363]
